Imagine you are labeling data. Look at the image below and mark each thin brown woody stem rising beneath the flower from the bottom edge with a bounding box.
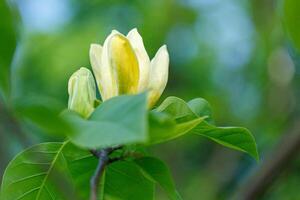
[90,149,111,200]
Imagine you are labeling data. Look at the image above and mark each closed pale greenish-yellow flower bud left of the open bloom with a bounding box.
[68,67,96,118]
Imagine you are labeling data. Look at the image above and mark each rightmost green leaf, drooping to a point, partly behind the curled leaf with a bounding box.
[188,99,259,160]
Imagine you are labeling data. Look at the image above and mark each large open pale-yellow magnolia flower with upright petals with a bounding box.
[90,29,169,107]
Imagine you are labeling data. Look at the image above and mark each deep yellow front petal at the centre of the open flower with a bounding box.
[108,34,139,94]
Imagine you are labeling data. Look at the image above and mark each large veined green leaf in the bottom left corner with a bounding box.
[1,142,77,200]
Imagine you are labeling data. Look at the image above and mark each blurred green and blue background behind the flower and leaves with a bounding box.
[0,0,300,200]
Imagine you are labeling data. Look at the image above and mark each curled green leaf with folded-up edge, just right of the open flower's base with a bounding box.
[149,97,206,144]
